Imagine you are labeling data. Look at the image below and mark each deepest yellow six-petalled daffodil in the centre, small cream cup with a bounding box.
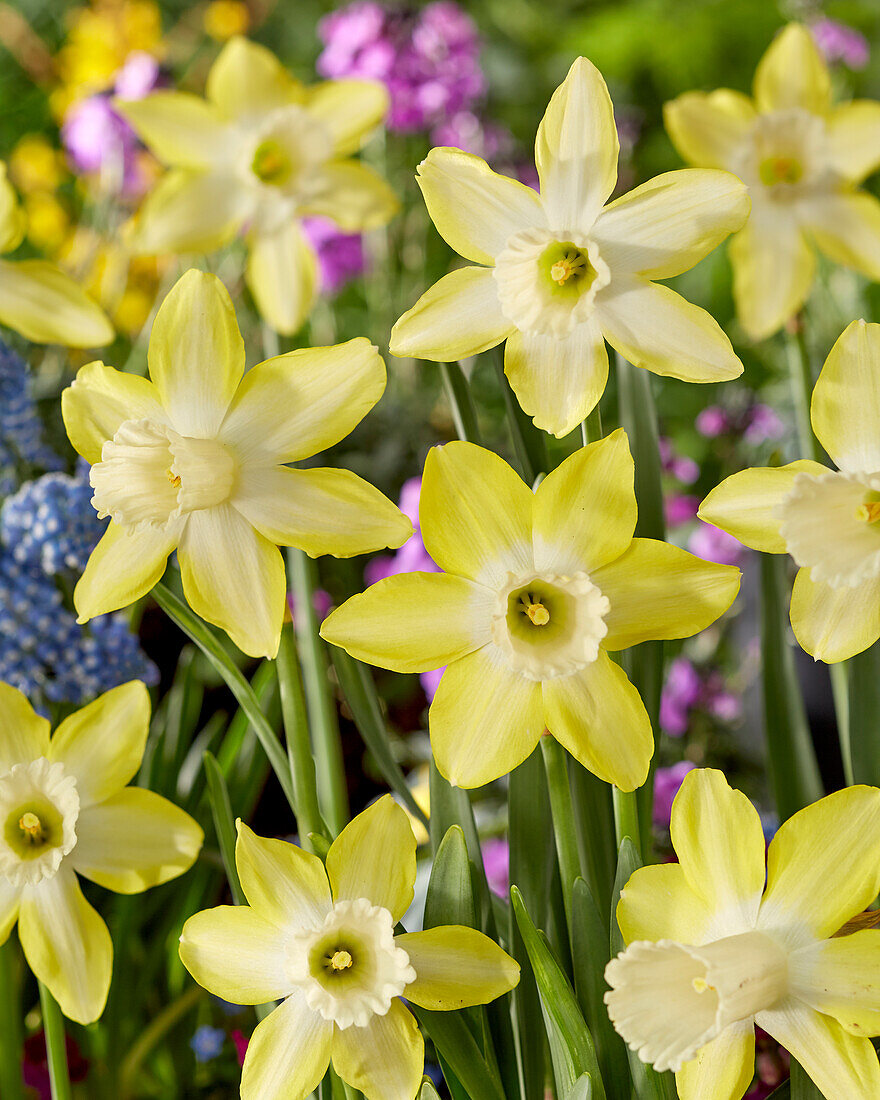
[321,430,739,791]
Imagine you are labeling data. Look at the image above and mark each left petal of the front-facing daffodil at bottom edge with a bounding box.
[179,905,293,1004]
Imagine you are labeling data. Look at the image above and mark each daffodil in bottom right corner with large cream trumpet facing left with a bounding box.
[605,769,880,1100]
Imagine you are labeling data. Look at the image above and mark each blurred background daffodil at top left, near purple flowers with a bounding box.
[119,37,397,333]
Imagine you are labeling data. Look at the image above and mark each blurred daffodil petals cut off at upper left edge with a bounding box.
[0,161,113,348]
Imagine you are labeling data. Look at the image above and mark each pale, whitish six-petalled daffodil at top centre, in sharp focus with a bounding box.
[391,57,749,436]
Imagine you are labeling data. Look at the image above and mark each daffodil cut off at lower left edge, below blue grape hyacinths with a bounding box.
[0,680,202,1024]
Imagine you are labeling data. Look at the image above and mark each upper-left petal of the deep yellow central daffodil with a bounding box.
[419,441,535,591]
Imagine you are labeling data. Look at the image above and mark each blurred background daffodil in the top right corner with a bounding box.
[664,23,880,340]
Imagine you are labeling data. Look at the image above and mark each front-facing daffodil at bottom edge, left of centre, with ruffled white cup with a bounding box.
[180,795,519,1100]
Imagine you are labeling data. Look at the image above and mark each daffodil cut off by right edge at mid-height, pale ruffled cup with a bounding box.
[700,321,880,663]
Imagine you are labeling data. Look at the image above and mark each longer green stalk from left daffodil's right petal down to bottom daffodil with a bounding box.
[287,547,349,836]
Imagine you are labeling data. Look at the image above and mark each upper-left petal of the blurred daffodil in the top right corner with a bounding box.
[663,88,757,168]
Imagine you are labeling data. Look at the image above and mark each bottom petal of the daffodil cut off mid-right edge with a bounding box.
[791,569,880,664]
